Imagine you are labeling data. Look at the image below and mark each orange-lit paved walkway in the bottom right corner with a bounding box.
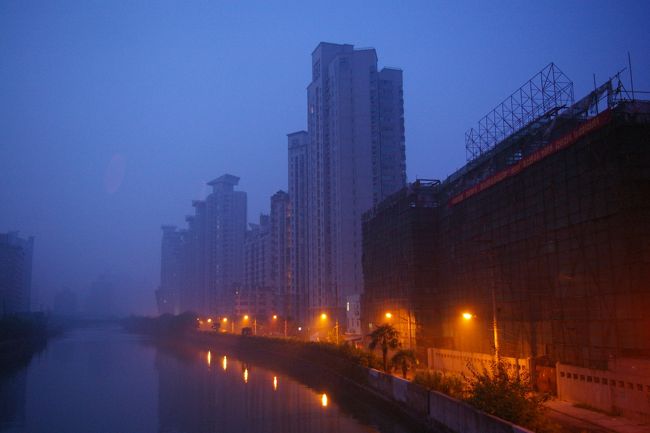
[546,400,650,433]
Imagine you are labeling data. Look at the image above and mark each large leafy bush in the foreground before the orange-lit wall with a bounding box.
[465,363,555,432]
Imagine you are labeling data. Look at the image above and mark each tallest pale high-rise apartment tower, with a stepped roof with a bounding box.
[306,43,406,323]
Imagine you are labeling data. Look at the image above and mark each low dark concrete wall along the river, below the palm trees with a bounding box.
[368,369,532,433]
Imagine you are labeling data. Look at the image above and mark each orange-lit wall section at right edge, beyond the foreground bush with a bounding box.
[556,363,650,421]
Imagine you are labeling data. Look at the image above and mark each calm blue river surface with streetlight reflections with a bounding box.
[0,328,416,433]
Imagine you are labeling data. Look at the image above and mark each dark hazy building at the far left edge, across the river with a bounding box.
[0,232,34,315]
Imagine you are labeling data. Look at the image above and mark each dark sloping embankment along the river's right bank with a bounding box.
[190,332,532,433]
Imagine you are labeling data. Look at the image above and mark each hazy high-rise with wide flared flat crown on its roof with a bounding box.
[205,174,247,315]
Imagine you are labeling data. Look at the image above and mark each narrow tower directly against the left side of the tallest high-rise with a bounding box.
[287,131,309,324]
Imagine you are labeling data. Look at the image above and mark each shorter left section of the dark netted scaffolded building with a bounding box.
[361,180,440,348]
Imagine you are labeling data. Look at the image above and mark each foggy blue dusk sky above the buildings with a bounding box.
[0,0,650,313]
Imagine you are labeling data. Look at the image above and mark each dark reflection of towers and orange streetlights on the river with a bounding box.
[156,344,368,433]
